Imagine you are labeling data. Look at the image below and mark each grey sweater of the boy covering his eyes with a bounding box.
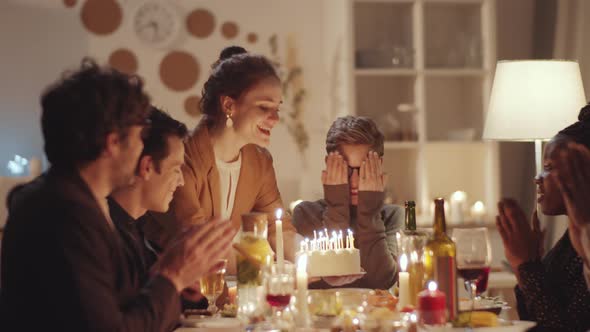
[293,184,404,289]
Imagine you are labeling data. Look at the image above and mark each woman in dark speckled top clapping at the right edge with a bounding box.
[497,106,590,331]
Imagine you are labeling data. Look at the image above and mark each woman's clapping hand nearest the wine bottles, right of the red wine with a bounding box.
[496,199,544,271]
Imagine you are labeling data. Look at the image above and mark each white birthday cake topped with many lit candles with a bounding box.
[299,231,361,277]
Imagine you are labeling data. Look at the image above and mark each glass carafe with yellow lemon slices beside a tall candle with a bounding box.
[234,213,273,323]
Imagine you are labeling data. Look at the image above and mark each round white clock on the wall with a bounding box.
[132,0,182,48]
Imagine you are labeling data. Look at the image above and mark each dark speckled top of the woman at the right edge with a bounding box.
[515,231,590,332]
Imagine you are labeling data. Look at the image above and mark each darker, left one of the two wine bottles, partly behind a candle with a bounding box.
[398,201,428,306]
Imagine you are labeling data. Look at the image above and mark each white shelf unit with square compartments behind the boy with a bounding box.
[348,0,500,224]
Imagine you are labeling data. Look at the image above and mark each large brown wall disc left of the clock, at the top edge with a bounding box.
[80,0,123,35]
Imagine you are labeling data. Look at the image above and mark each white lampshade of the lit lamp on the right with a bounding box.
[483,60,586,141]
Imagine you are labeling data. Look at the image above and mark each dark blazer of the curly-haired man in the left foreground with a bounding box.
[0,169,180,332]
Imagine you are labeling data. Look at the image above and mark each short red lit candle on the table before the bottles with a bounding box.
[418,281,447,325]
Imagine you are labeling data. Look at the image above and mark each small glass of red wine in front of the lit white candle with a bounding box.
[264,262,295,328]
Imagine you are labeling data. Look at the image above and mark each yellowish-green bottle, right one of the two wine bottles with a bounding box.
[424,198,457,320]
